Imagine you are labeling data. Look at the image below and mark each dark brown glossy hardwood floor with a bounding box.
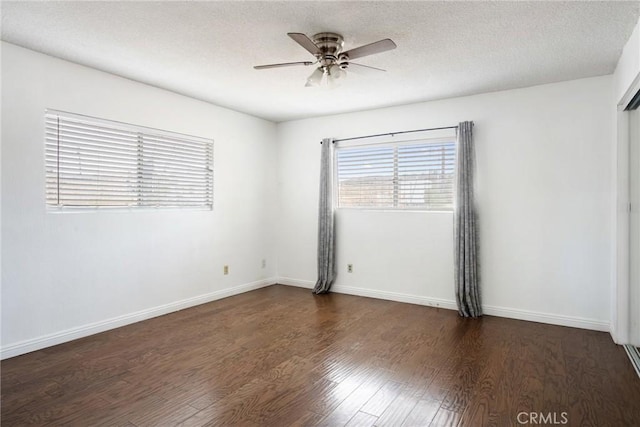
[1,286,640,426]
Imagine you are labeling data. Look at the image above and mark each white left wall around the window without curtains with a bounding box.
[2,43,277,357]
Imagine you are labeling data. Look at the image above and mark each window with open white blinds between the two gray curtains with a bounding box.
[336,138,456,211]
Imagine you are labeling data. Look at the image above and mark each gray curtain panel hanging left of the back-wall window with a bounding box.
[313,138,336,294]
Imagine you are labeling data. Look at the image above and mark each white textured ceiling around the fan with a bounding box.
[0,1,640,121]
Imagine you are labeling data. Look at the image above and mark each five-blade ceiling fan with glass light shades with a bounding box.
[253,33,396,87]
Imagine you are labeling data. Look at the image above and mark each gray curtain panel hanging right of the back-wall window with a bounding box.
[454,122,482,317]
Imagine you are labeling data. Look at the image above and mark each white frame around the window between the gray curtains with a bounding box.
[331,134,458,213]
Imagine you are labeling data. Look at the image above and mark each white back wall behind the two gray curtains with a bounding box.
[278,76,614,330]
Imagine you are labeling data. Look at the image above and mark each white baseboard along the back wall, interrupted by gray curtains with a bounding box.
[278,277,610,332]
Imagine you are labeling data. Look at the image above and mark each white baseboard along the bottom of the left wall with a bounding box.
[0,278,277,359]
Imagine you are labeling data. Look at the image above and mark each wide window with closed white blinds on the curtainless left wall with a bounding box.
[45,110,213,209]
